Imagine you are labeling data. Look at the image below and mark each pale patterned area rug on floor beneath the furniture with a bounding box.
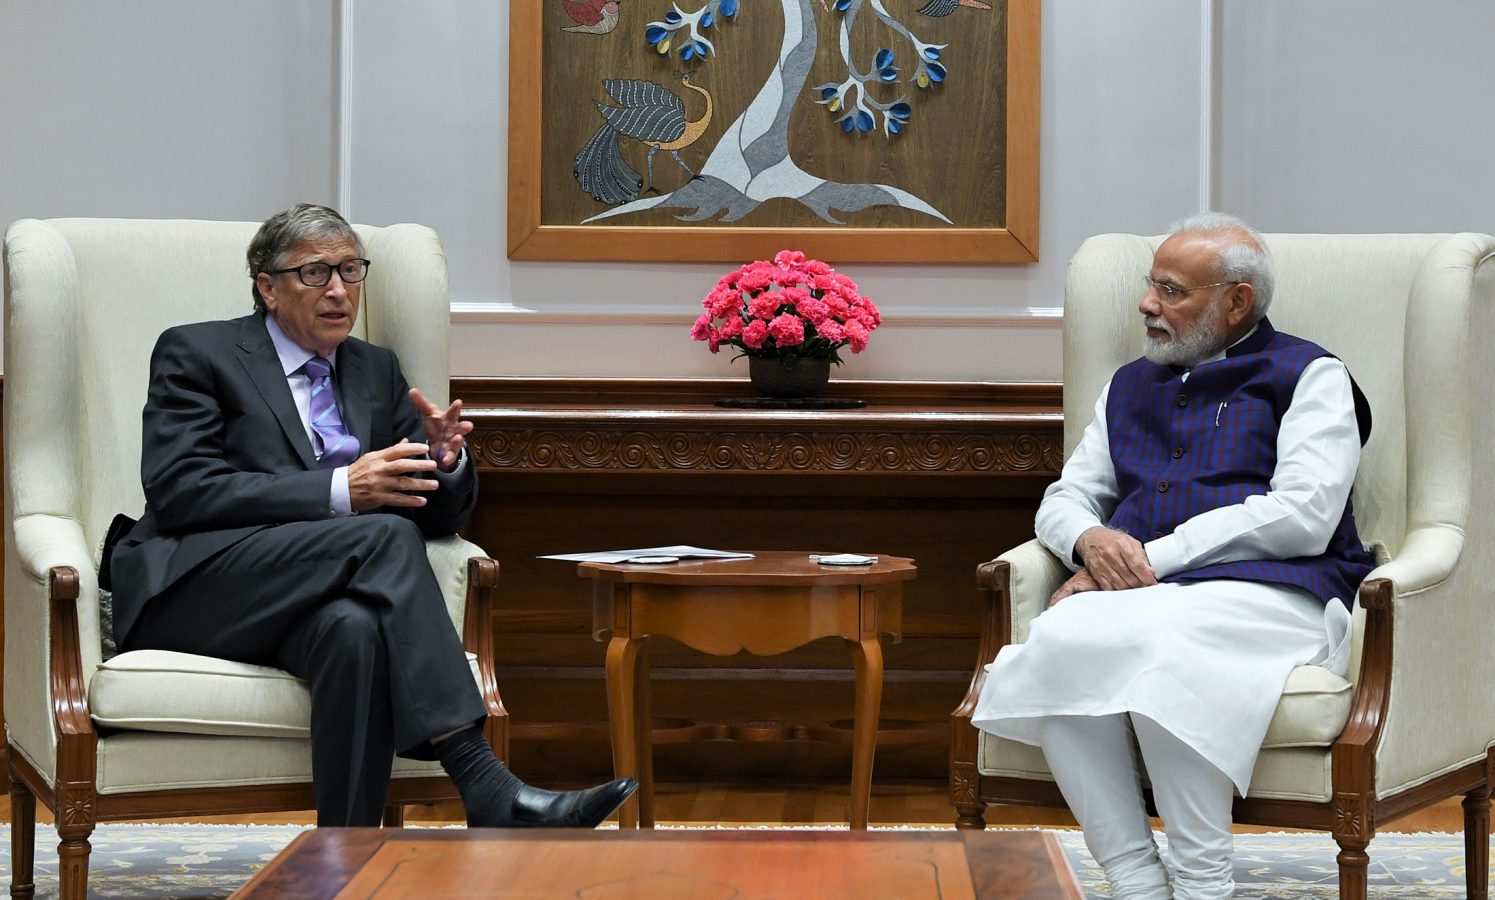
[0,825,1464,900]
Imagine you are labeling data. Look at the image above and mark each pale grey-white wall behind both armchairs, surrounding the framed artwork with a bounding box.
[0,0,1495,380]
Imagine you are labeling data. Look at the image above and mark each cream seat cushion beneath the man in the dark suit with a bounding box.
[88,650,477,740]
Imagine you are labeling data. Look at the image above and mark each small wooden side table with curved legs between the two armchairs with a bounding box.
[577,550,918,828]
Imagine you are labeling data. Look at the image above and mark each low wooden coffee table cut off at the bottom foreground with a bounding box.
[235,828,1082,900]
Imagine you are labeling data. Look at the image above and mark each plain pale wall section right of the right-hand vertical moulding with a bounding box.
[1217,0,1495,232]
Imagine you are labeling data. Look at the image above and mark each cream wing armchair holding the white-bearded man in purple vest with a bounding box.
[951,235,1495,899]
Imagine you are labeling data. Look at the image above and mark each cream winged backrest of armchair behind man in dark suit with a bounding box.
[4,218,450,674]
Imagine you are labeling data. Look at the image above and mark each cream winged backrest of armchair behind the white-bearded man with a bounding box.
[1063,235,1492,556]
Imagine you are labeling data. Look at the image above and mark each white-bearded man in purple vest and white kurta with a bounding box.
[973,212,1374,900]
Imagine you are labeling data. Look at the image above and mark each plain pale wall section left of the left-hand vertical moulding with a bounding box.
[0,0,338,226]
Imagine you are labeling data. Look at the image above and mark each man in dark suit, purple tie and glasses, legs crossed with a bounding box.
[112,203,637,828]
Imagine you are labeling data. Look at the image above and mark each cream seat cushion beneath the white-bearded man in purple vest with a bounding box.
[979,665,1354,780]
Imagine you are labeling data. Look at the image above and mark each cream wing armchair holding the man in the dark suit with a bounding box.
[4,218,508,897]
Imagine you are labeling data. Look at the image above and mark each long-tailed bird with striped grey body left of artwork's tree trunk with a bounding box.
[571,72,712,206]
